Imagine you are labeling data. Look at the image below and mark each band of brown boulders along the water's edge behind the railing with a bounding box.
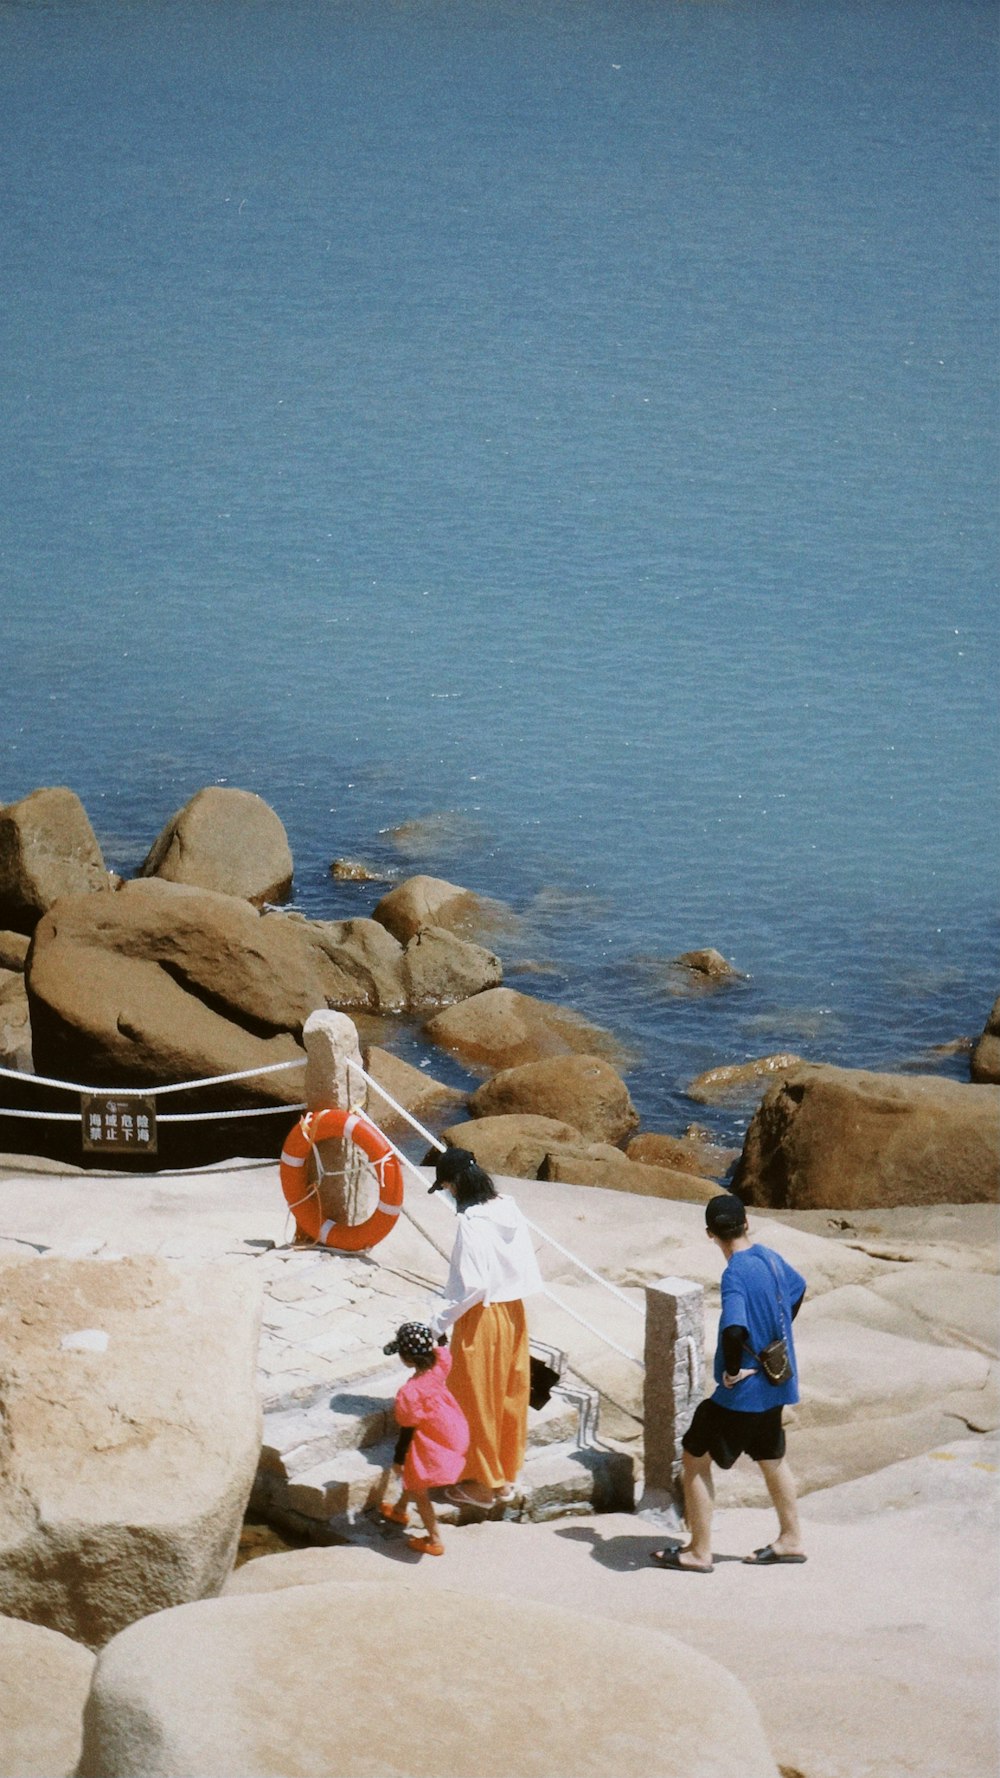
[0,786,1000,1207]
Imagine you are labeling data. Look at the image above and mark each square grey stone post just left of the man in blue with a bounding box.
[641,1278,705,1511]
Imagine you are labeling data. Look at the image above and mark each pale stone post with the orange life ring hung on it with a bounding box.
[302,1008,379,1223]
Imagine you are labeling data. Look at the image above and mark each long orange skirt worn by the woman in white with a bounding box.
[448,1301,530,1488]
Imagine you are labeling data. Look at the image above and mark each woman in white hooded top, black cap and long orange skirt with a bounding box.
[423,1149,543,1506]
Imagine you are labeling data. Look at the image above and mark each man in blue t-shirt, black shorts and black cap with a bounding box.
[651,1191,806,1574]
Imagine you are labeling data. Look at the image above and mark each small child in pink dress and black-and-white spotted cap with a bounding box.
[374,1321,470,1556]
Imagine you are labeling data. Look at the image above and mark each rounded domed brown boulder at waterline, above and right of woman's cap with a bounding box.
[468,1056,639,1141]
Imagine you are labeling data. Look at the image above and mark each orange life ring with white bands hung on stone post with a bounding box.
[279,1106,402,1253]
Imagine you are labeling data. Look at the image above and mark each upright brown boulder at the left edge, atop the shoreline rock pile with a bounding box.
[0,786,109,932]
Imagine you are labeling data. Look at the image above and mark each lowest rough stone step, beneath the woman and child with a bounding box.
[251,1438,635,1543]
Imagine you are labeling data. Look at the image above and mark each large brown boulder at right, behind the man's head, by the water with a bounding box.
[733,1065,1000,1209]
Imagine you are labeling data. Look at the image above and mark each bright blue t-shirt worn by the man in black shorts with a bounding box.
[712,1241,806,1414]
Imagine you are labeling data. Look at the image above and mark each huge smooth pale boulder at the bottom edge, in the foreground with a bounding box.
[78,1577,778,1778]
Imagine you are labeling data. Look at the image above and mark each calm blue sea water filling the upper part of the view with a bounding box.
[0,0,1000,1134]
